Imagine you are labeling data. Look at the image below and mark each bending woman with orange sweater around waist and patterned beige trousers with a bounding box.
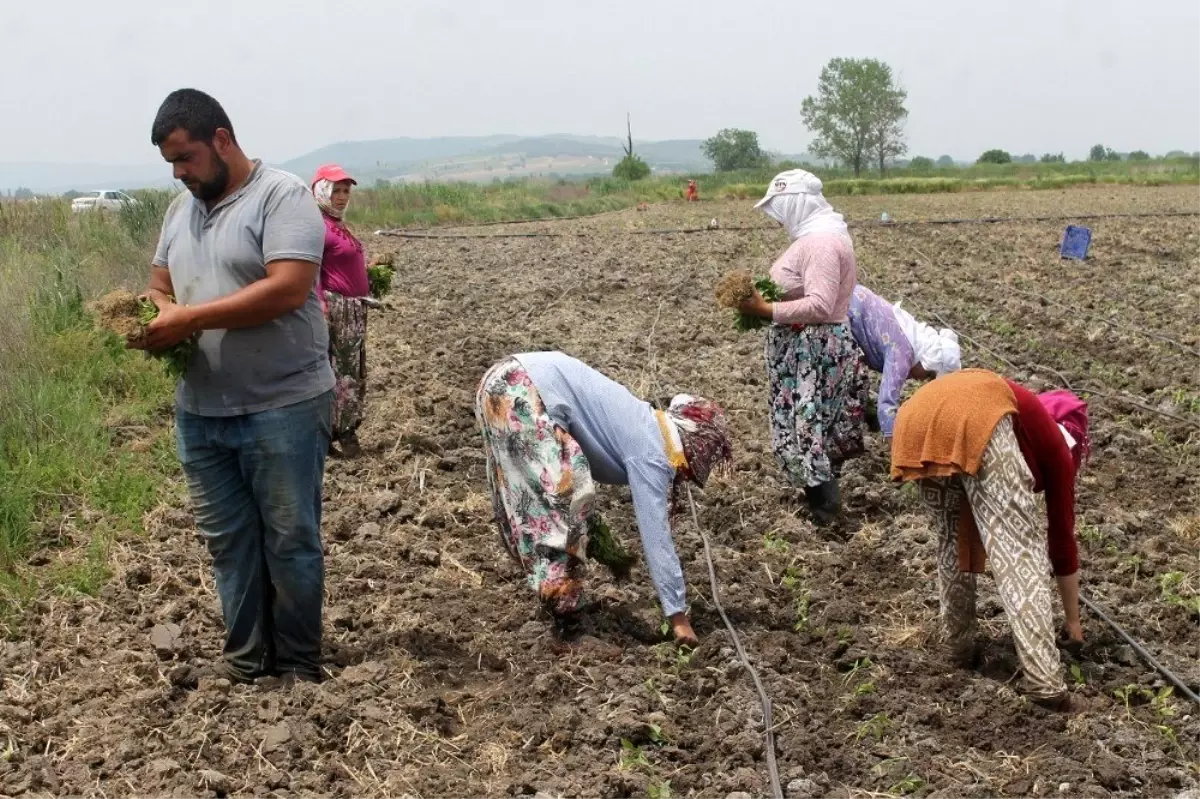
[892,370,1090,711]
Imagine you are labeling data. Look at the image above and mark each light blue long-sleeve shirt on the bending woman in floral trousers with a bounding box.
[515,353,688,615]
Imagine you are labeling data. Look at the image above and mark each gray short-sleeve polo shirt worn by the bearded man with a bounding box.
[154,162,334,416]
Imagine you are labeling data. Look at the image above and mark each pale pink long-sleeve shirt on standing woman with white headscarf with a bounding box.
[770,233,858,325]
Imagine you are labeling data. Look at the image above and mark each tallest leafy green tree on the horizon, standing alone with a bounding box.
[800,59,908,175]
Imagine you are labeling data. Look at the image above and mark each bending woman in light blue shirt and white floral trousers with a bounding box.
[475,353,732,644]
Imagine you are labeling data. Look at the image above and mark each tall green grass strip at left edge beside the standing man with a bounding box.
[0,196,178,633]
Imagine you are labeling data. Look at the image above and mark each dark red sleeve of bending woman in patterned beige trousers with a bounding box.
[1008,380,1079,577]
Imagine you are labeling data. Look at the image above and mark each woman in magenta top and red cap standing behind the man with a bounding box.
[312,164,371,457]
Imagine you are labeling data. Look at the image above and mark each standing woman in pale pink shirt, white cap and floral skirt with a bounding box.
[740,169,868,524]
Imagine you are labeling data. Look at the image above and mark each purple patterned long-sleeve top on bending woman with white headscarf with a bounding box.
[850,286,917,438]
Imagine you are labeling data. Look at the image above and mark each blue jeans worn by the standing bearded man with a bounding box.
[176,391,334,679]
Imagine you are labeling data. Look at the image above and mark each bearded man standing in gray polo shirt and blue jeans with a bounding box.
[132,89,334,681]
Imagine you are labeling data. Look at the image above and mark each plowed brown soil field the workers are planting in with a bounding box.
[0,187,1200,799]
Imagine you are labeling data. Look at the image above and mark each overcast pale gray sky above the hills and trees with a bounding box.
[0,0,1200,164]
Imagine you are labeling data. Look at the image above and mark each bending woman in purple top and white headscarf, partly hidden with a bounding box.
[850,286,962,439]
